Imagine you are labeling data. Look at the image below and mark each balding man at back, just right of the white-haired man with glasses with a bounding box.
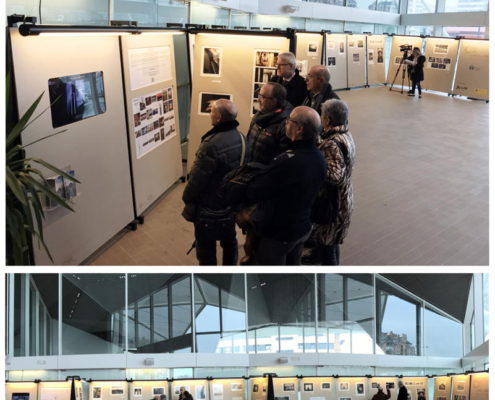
[303,65,340,115]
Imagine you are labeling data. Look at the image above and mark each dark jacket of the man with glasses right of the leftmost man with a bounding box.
[247,101,293,164]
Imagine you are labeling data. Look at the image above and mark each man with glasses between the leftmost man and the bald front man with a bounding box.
[247,82,292,164]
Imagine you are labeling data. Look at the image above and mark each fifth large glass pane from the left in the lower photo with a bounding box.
[247,274,315,353]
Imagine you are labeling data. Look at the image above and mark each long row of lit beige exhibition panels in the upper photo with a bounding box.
[10,26,488,265]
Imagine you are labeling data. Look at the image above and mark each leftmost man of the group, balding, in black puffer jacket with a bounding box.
[182,99,245,265]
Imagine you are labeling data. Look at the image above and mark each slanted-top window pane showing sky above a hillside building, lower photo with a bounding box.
[376,281,419,355]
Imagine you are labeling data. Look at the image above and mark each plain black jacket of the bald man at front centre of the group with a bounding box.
[247,140,326,241]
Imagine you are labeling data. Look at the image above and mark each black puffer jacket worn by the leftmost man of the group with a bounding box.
[182,121,242,211]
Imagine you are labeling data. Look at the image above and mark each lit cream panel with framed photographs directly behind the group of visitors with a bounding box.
[187,33,289,170]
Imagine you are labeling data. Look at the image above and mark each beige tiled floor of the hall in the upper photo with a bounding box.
[91,87,488,265]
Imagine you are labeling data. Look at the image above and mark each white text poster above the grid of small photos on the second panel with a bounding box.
[128,46,172,90]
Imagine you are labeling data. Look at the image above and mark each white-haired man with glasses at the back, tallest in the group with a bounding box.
[270,52,308,107]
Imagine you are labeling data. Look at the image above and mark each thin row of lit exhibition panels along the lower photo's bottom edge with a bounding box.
[6,372,489,400]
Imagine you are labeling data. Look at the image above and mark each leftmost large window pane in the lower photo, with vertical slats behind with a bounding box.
[9,274,58,357]
